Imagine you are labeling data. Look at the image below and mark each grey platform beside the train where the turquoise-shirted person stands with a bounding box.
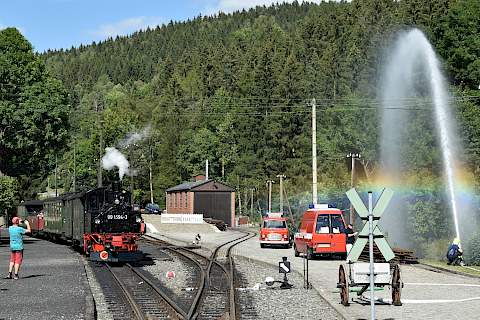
[0,229,93,320]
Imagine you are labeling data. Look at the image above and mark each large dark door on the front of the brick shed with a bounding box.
[193,191,232,227]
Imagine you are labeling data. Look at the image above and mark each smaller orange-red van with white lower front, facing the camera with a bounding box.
[260,213,292,248]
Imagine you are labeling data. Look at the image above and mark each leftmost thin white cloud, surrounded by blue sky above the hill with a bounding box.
[94,16,165,38]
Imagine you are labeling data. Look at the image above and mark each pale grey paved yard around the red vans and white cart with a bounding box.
[149,225,480,320]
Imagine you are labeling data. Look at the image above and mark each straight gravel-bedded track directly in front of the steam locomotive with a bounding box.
[94,264,186,320]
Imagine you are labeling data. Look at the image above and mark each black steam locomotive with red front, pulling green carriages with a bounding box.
[17,182,145,262]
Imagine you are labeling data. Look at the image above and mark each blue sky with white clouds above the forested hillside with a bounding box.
[0,0,319,52]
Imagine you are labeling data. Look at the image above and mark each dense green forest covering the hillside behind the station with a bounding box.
[0,0,480,251]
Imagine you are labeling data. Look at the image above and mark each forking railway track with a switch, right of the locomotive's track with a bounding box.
[145,232,255,320]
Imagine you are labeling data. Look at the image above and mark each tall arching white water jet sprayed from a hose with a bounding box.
[381,29,460,245]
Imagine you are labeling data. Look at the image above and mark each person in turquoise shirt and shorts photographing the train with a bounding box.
[7,217,32,280]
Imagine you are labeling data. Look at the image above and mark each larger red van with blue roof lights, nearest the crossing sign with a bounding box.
[294,204,347,259]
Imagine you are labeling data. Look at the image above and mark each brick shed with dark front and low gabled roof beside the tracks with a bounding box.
[165,175,235,227]
